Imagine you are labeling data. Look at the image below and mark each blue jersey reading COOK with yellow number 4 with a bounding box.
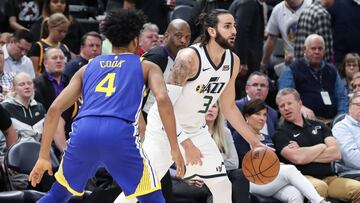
[75,53,145,123]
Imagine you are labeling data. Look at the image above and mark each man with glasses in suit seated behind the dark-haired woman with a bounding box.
[228,71,278,162]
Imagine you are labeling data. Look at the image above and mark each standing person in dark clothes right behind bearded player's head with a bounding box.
[229,0,265,99]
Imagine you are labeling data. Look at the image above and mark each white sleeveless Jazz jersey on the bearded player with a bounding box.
[174,44,234,134]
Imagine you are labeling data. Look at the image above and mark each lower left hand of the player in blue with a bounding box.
[29,158,53,187]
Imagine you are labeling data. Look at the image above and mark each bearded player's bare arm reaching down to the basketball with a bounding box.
[220,54,264,147]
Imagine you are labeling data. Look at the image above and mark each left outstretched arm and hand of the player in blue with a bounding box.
[29,67,85,187]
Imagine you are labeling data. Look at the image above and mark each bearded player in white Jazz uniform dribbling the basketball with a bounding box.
[115,9,264,203]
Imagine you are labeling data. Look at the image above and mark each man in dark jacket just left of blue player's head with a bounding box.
[64,31,102,80]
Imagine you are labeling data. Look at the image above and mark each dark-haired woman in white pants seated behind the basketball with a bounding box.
[243,99,326,203]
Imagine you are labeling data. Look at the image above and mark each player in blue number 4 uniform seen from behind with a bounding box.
[29,10,184,203]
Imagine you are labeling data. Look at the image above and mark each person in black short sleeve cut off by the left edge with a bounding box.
[0,105,17,164]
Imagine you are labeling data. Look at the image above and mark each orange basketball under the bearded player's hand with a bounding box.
[242,147,280,185]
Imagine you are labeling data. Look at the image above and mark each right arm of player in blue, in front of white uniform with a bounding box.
[142,60,185,177]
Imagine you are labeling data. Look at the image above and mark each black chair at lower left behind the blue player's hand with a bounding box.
[4,141,59,192]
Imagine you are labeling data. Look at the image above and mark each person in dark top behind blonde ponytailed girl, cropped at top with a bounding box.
[30,0,84,54]
